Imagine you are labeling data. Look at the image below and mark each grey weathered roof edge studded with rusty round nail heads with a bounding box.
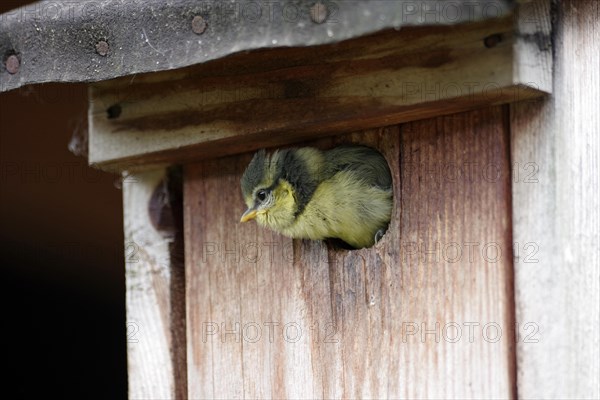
[0,0,514,92]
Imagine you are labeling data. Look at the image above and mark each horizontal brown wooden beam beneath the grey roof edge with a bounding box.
[89,6,551,169]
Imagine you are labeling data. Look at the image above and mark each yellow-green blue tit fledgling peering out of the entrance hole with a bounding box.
[241,145,392,248]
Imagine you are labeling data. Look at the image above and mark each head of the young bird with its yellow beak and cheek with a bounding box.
[241,150,298,230]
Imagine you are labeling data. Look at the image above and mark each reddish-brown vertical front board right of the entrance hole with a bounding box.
[396,107,516,398]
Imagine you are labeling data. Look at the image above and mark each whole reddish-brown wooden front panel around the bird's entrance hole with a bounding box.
[184,107,515,399]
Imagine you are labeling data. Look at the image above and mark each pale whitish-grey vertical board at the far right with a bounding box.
[511,0,600,399]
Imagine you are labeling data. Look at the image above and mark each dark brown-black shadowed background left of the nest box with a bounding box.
[0,1,127,399]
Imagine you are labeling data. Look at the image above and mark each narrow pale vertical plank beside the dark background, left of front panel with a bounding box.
[123,169,187,399]
